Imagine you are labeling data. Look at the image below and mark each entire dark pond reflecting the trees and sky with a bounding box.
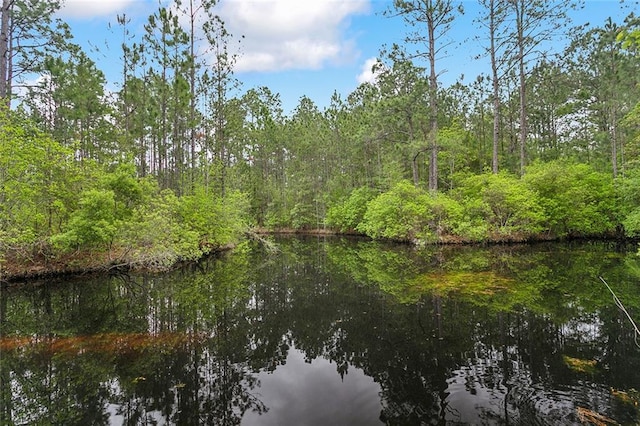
[0,238,640,425]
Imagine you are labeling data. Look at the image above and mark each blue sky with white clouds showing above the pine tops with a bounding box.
[58,0,640,114]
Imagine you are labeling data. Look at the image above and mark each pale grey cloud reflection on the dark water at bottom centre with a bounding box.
[242,347,382,426]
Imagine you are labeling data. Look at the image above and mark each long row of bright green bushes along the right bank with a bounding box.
[327,160,640,243]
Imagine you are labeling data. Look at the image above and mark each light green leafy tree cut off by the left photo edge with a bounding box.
[0,107,80,251]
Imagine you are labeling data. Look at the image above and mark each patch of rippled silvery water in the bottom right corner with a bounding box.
[443,363,638,426]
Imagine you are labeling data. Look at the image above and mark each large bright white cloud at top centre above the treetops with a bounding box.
[219,0,370,72]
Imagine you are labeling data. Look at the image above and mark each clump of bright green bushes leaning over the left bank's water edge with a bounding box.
[50,165,248,268]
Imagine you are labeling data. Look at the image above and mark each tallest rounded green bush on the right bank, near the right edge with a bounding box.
[524,161,616,237]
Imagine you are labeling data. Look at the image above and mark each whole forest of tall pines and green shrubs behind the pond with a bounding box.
[0,0,640,280]
